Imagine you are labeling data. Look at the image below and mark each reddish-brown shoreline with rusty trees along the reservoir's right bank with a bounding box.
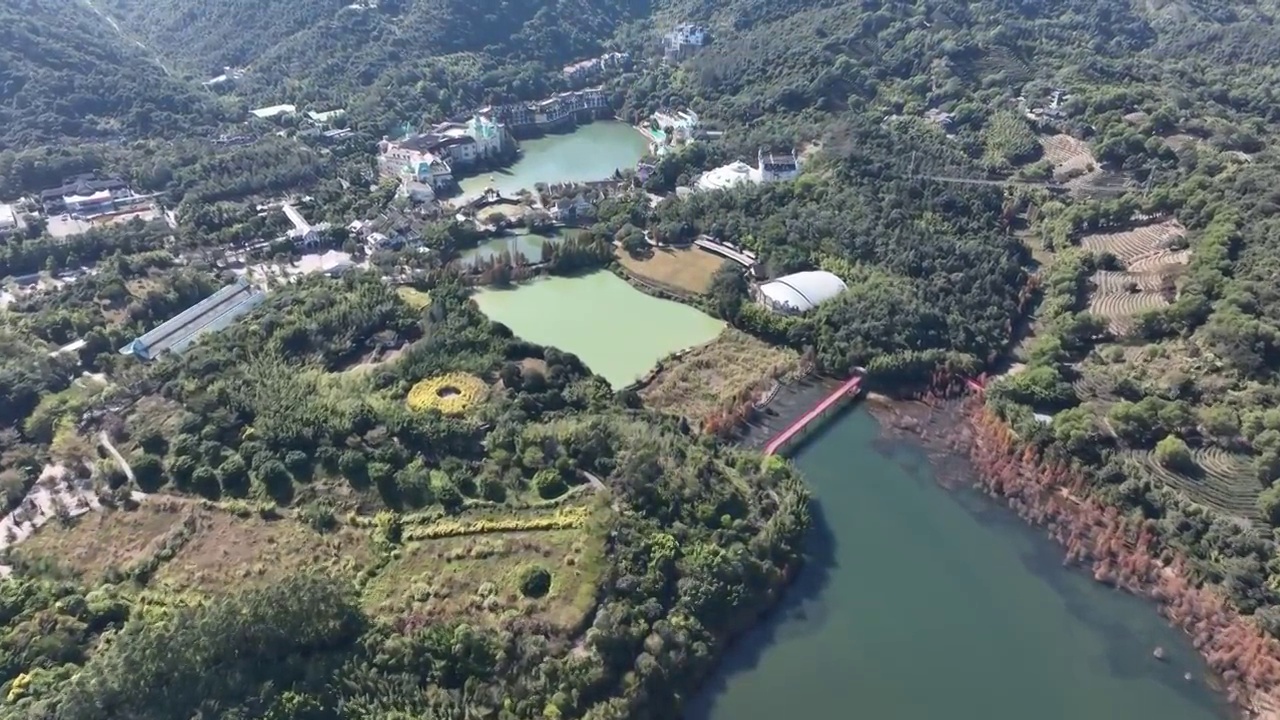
[867,396,1280,720]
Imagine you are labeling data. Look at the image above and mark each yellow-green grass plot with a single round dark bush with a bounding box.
[365,529,604,632]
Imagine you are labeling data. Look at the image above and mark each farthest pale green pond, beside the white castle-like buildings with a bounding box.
[458,120,649,197]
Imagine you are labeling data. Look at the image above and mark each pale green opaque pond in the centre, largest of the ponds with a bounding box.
[475,270,724,388]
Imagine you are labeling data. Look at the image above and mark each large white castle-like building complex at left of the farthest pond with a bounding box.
[378,115,512,202]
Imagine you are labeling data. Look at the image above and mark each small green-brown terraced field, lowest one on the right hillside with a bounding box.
[1128,447,1262,524]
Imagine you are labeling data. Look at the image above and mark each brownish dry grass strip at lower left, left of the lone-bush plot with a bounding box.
[14,498,374,592]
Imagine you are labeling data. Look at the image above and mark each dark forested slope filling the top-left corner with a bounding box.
[0,0,219,150]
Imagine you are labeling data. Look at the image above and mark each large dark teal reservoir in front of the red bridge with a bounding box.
[686,407,1231,720]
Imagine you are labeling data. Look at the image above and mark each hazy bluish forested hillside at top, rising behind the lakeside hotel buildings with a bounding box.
[92,0,650,123]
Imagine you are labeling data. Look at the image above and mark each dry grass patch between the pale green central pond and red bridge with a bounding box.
[640,329,800,418]
